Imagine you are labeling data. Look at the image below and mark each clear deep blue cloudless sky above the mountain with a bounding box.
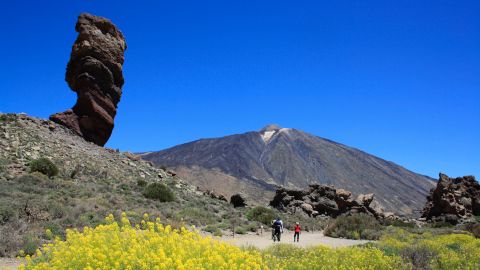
[0,0,480,178]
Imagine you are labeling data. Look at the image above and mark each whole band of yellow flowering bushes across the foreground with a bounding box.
[19,214,480,270]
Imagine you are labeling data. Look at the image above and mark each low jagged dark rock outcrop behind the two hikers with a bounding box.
[270,184,384,218]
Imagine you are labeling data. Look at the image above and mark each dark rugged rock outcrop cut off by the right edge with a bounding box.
[422,173,480,224]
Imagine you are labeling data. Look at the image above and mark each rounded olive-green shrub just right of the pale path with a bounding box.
[324,213,382,240]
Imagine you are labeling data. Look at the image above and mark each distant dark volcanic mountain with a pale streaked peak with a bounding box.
[142,125,434,214]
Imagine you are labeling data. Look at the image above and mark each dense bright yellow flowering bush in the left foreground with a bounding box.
[19,214,267,270]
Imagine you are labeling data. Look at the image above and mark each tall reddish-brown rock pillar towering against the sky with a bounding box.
[50,13,127,146]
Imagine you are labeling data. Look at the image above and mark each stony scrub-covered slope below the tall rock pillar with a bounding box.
[0,114,255,257]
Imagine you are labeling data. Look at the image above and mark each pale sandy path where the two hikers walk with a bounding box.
[221,232,370,249]
